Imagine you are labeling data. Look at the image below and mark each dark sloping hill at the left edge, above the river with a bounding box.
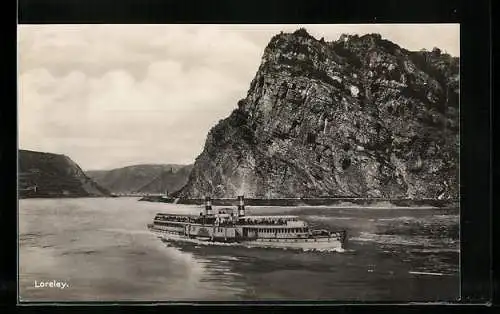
[18,150,110,198]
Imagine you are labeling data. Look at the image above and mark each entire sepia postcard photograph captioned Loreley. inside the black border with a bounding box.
[17,23,461,303]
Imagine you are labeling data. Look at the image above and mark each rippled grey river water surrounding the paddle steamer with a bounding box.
[19,198,460,302]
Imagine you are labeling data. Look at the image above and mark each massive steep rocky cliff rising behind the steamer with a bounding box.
[178,30,459,199]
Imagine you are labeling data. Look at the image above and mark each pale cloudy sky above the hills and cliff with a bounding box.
[18,24,460,170]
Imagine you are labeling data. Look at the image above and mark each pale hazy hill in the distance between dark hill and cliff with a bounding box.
[86,164,192,193]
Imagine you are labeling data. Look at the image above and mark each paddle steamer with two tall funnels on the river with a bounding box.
[148,196,347,251]
